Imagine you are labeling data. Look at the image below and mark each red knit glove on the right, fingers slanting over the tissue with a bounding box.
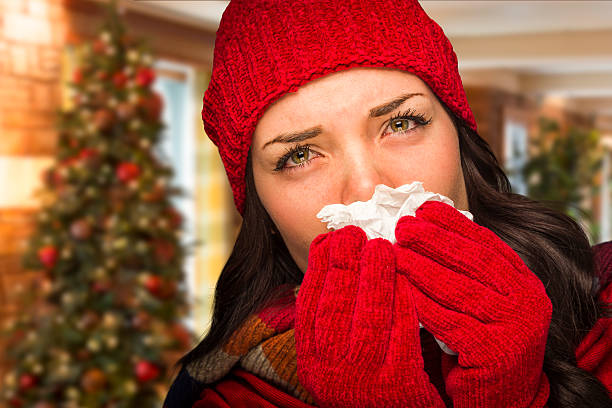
[394,201,552,408]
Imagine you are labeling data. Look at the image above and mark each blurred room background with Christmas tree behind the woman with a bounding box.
[0,0,612,408]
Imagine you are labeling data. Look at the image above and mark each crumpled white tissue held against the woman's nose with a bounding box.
[317,181,474,356]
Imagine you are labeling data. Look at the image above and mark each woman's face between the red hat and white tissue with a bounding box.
[251,67,469,272]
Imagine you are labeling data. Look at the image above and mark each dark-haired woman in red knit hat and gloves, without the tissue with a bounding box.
[165,0,612,408]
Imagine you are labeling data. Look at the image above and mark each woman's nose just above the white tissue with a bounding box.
[341,143,391,205]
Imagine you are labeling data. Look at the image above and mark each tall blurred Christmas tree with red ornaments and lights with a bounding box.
[1,2,192,408]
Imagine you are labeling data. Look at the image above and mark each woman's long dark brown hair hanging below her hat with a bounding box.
[178,101,612,408]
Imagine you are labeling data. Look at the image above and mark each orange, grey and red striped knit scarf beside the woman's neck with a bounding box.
[186,286,314,404]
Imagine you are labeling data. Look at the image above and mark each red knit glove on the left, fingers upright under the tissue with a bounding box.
[295,225,444,407]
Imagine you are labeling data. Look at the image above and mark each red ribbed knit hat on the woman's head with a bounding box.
[202,0,476,214]
